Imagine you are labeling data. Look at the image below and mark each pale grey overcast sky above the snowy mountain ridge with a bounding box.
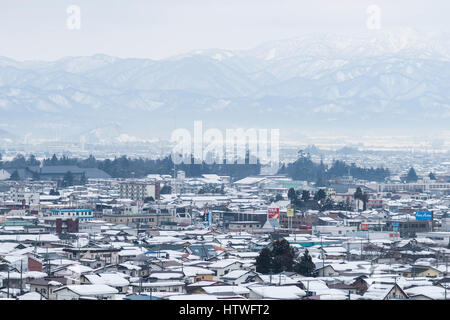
[0,0,450,60]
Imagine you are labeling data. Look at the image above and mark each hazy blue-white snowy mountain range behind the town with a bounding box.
[0,30,450,141]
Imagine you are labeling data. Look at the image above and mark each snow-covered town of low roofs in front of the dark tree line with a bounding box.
[0,161,450,300]
